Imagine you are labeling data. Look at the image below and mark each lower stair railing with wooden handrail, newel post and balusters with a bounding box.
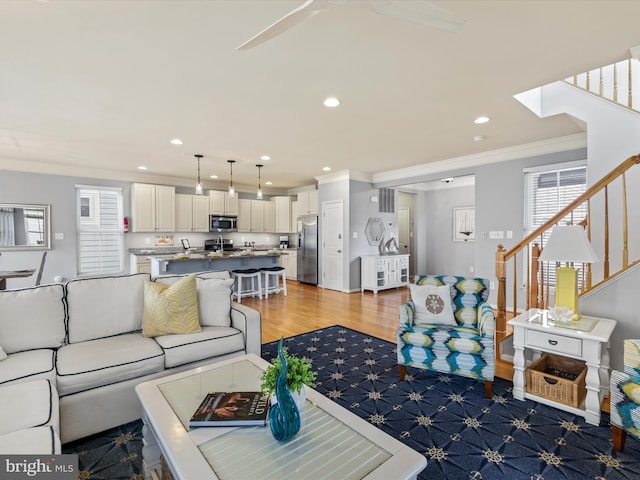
[495,155,640,378]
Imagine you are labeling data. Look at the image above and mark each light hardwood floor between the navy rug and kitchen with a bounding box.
[242,281,513,380]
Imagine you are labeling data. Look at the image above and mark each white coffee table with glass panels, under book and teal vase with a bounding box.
[136,354,427,480]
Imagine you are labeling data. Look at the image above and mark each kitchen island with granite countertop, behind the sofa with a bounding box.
[148,250,282,277]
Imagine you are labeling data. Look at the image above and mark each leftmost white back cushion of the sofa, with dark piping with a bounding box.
[0,284,65,354]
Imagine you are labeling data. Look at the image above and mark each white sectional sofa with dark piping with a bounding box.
[0,272,261,453]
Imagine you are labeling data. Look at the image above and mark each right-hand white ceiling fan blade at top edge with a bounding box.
[369,0,465,32]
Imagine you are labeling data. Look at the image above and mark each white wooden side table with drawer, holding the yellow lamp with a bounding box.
[507,308,616,425]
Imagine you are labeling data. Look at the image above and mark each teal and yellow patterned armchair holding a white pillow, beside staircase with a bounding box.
[397,275,495,398]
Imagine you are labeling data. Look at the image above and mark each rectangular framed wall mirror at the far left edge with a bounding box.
[0,203,51,252]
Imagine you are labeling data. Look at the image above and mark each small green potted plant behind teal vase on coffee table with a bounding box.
[260,350,318,410]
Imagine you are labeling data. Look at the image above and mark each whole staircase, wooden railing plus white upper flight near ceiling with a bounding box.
[495,52,640,379]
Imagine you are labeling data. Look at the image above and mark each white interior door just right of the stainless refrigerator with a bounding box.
[322,200,344,291]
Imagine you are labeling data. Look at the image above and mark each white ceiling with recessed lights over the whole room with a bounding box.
[0,0,640,193]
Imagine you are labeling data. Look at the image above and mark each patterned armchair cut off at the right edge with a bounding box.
[609,340,640,452]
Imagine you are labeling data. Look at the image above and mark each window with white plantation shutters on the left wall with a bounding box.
[76,186,124,275]
